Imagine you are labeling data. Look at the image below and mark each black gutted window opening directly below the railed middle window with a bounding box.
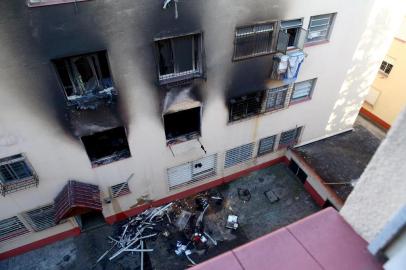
[163,107,201,143]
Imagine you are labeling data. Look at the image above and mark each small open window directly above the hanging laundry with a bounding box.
[281,19,307,50]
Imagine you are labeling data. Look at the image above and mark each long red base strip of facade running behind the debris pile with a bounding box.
[106,156,289,224]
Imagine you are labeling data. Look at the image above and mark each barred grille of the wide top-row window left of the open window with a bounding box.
[234,23,274,60]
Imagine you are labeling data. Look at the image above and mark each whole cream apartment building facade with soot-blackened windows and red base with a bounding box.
[0,0,402,258]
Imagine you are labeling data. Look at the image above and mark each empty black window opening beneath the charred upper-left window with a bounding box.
[81,127,131,167]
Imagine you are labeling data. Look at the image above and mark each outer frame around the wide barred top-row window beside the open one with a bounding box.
[232,20,279,62]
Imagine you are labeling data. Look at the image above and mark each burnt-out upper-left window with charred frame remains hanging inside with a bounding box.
[53,51,114,100]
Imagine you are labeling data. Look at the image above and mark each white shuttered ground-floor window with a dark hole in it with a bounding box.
[168,154,217,190]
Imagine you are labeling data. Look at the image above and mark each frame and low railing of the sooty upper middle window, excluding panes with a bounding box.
[154,31,204,85]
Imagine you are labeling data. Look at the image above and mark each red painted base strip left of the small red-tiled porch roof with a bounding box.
[0,227,80,260]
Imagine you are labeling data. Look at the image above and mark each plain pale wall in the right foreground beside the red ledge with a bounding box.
[341,108,406,241]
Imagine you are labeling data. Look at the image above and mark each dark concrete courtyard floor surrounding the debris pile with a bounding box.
[0,164,320,270]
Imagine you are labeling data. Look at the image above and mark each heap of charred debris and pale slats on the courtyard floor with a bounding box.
[97,192,232,269]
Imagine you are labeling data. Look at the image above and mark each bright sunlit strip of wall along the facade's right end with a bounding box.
[325,1,403,134]
